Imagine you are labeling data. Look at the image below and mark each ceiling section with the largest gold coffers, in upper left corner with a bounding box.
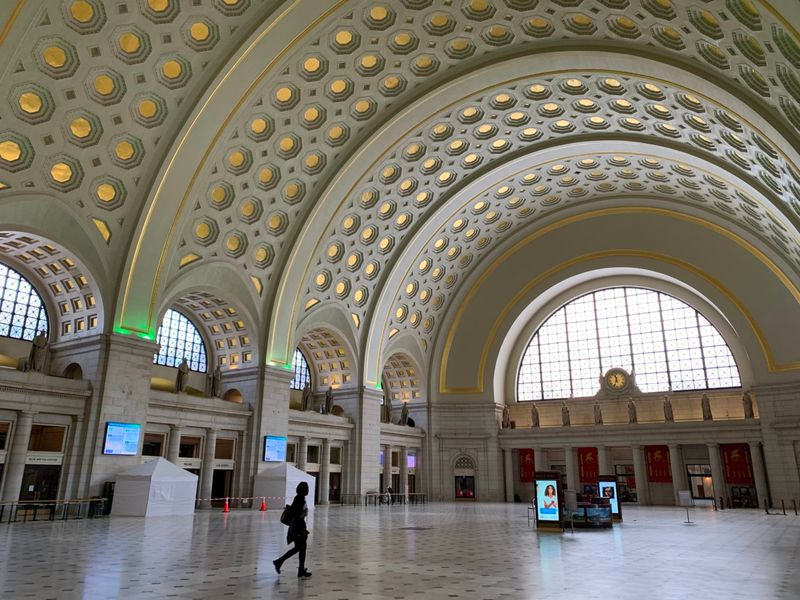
[0,0,276,262]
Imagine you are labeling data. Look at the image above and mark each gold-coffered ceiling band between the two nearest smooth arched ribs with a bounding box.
[103,0,796,340]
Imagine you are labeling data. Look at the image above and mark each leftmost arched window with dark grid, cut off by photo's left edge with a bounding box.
[0,263,49,341]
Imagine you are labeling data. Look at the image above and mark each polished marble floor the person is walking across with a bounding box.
[0,503,800,600]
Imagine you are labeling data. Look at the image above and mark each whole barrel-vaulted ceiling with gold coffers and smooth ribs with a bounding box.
[0,0,800,383]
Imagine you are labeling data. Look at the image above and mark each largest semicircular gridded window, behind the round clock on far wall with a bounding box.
[517,287,741,401]
